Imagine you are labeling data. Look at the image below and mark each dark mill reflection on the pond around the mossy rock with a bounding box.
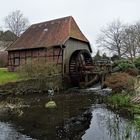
[0,95,96,140]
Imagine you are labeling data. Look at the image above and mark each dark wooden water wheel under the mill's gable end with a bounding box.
[69,50,95,86]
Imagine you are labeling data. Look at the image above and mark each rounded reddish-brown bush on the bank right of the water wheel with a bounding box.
[105,72,134,92]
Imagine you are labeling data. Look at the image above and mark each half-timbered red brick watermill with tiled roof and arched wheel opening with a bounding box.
[7,16,92,84]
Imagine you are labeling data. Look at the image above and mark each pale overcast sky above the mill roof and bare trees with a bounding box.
[0,0,140,53]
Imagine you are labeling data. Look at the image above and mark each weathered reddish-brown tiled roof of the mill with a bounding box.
[7,16,89,51]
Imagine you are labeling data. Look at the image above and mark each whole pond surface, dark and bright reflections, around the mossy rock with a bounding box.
[0,93,140,140]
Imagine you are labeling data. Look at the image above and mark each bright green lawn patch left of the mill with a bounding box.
[0,68,20,84]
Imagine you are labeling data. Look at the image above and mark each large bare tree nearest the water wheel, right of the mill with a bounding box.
[96,20,125,58]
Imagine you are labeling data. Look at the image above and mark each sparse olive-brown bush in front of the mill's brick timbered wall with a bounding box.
[17,59,61,79]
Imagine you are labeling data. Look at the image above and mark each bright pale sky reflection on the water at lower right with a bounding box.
[82,105,140,140]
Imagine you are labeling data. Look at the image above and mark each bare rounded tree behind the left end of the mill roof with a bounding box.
[5,10,29,36]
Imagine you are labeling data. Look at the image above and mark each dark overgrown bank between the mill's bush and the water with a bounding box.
[0,75,64,95]
